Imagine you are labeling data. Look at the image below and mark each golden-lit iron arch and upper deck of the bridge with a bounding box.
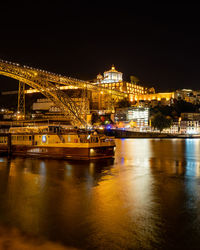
[0,60,126,127]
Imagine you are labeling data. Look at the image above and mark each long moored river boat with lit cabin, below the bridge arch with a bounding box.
[0,125,115,160]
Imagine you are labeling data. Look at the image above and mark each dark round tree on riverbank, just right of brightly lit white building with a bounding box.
[151,113,172,132]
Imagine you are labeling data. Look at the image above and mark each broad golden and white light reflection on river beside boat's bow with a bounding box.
[88,139,159,249]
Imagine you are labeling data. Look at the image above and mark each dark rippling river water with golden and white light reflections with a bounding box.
[0,139,200,249]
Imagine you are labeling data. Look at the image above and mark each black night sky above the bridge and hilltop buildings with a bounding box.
[0,1,200,92]
